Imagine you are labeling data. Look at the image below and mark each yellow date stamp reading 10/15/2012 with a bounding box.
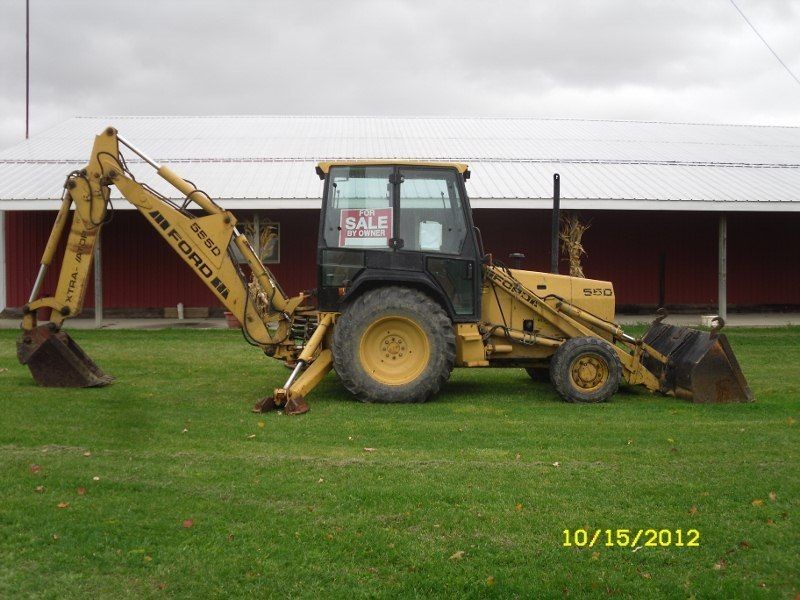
[561,528,700,550]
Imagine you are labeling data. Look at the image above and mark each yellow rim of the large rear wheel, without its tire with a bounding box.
[358,316,431,385]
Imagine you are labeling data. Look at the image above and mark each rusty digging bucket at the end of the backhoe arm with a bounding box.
[17,325,114,387]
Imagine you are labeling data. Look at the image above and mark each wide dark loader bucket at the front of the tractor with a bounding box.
[642,320,754,402]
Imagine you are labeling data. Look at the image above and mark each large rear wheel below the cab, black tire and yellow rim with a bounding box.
[333,286,456,403]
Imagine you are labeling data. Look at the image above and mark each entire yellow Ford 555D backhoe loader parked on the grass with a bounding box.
[17,127,753,414]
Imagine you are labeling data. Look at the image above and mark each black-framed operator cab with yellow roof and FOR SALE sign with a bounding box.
[317,161,481,322]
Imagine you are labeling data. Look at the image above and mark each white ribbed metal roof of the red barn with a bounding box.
[0,116,800,211]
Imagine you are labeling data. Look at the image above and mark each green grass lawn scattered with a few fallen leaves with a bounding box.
[0,328,800,598]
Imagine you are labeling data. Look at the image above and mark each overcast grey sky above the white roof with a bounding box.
[0,0,800,149]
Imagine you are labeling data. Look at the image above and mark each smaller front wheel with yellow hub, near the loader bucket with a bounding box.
[550,337,622,402]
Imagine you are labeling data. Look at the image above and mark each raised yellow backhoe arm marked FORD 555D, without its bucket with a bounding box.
[23,127,305,354]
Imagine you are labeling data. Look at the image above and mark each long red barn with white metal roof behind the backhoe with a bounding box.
[0,116,800,315]
